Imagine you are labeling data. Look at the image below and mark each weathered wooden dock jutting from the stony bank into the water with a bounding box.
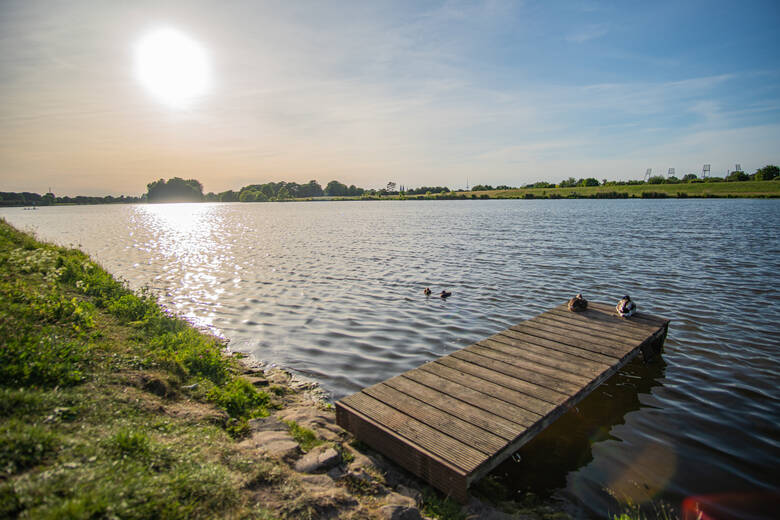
[336,302,669,502]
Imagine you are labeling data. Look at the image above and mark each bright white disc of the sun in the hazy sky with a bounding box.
[135,28,209,108]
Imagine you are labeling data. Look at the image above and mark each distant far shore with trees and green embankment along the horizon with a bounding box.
[0,165,780,206]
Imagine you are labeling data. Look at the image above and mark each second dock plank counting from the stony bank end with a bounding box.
[363,383,506,455]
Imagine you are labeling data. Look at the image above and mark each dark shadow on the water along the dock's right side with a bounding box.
[489,356,666,500]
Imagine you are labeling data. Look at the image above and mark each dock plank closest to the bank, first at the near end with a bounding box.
[341,392,485,473]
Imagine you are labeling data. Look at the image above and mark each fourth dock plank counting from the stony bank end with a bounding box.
[401,369,541,427]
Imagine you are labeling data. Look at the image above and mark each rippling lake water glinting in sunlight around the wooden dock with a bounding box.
[0,200,780,518]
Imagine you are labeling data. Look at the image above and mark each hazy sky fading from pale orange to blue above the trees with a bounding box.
[0,0,780,195]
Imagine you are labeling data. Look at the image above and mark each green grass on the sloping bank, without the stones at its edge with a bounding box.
[0,220,278,519]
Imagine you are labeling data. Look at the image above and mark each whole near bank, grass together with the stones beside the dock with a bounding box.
[0,219,592,520]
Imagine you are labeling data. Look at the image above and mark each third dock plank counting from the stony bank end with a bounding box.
[385,376,526,442]
